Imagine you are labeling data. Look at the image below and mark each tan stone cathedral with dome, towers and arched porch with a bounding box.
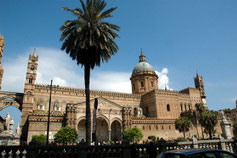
[0,36,226,142]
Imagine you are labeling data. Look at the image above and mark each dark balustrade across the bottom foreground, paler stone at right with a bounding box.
[0,138,237,158]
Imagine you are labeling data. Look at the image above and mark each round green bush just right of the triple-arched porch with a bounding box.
[123,127,143,142]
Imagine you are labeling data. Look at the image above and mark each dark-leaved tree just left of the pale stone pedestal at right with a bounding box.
[199,111,218,139]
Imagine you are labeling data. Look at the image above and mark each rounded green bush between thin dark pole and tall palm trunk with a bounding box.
[54,126,77,145]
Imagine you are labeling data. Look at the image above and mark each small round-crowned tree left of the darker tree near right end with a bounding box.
[175,116,191,138]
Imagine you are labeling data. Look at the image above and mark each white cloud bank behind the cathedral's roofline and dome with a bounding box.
[2,47,169,93]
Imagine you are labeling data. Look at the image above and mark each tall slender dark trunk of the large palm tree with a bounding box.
[84,64,91,145]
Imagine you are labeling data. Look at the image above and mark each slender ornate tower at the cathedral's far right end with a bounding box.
[194,73,207,106]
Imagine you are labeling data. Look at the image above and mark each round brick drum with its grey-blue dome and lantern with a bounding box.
[130,51,158,94]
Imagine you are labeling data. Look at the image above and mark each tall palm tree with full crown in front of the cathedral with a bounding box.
[60,0,120,144]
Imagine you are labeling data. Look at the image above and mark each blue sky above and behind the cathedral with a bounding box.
[0,0,237,128]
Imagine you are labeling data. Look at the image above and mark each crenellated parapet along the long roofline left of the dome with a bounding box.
[35,84,141,99]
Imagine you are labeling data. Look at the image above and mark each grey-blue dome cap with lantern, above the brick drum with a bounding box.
[132,53,155,74]
